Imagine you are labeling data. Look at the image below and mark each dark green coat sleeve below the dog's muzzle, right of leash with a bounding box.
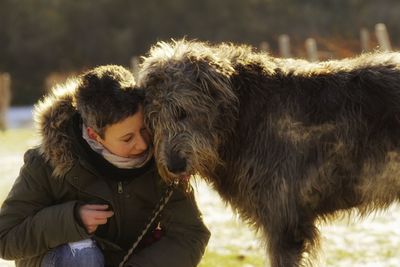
[126,187,210,267]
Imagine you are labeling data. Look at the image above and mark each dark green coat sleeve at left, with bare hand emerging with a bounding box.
[0,152,88,260]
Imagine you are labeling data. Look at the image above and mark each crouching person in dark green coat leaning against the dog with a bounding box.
[0,65,210,267]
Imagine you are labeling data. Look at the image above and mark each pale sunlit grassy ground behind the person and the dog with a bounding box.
[0,109,400,267]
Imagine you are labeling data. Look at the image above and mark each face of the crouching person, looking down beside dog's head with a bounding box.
[89,107,150,158]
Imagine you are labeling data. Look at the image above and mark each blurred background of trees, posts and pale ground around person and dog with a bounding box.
[0,0,400,267]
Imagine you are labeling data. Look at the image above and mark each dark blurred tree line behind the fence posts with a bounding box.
[0,0,400,104]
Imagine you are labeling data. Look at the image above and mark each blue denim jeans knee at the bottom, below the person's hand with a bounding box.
[41,239,104,267]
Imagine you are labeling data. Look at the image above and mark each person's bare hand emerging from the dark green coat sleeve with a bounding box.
[79,204,114,234]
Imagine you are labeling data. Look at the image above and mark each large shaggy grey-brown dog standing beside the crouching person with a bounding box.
[139,40,400,267]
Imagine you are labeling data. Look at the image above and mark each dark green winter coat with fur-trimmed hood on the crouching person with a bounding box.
[0,82,210,267]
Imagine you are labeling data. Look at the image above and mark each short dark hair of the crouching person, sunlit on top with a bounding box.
[76,65,144,138]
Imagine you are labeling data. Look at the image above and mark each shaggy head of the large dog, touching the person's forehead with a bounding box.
[139,40,237,184]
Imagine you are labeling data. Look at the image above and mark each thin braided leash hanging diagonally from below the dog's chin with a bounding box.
[119,179,179,267]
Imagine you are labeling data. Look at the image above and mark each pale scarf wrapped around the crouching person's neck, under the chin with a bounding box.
[82,125,153,169]
